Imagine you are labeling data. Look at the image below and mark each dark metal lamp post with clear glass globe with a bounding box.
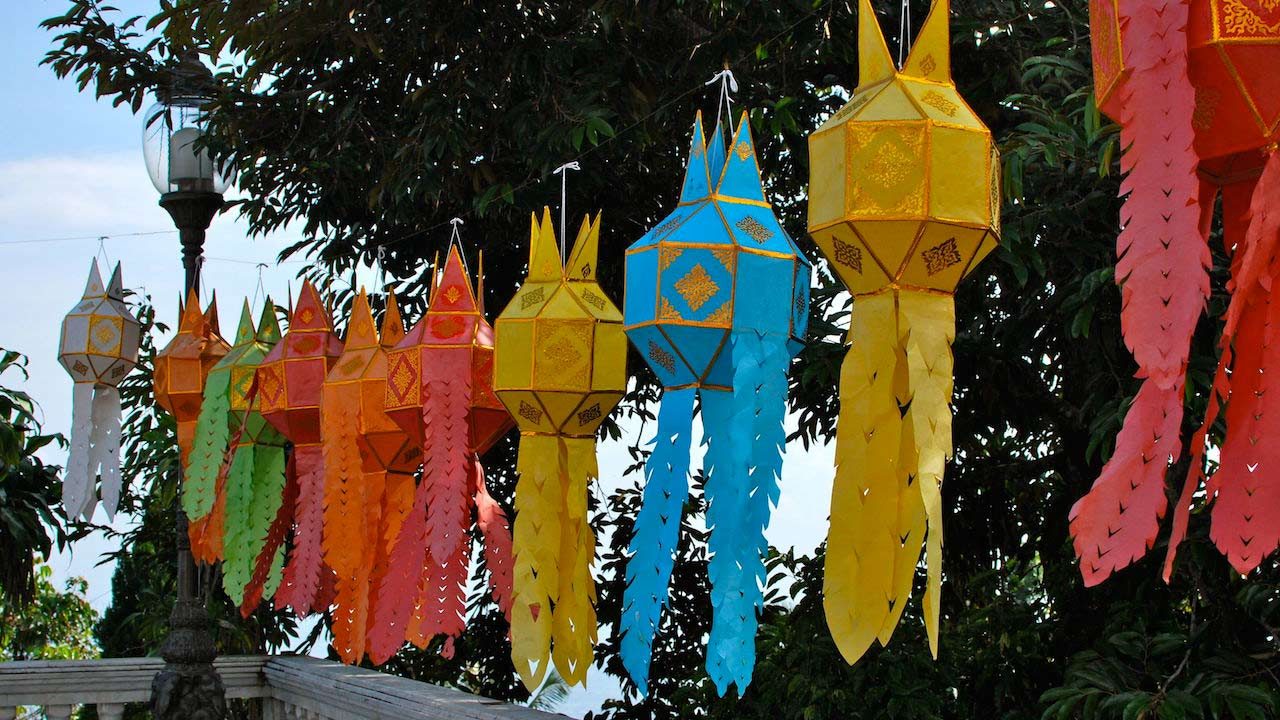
[142,74,230,720]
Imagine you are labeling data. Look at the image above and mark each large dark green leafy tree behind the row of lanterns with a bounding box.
[46,0,1280,720]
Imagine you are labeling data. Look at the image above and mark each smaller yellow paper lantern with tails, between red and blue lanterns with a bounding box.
[495,209,626,691]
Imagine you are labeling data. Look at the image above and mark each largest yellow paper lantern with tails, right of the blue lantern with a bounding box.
[809,0,1000,664]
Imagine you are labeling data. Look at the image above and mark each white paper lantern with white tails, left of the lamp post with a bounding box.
[58,258,138,520]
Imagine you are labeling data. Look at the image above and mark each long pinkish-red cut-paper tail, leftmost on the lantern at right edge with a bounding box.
[1070,0,1212,585]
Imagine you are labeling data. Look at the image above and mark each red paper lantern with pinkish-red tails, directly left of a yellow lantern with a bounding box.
[367,242,511,664]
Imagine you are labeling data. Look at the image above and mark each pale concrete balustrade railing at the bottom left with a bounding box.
[0,656,563,720]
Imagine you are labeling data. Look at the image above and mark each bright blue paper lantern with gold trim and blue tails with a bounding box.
[622,113,810,694]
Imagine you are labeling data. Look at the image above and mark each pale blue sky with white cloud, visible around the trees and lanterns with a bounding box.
[0,0,835,714]
